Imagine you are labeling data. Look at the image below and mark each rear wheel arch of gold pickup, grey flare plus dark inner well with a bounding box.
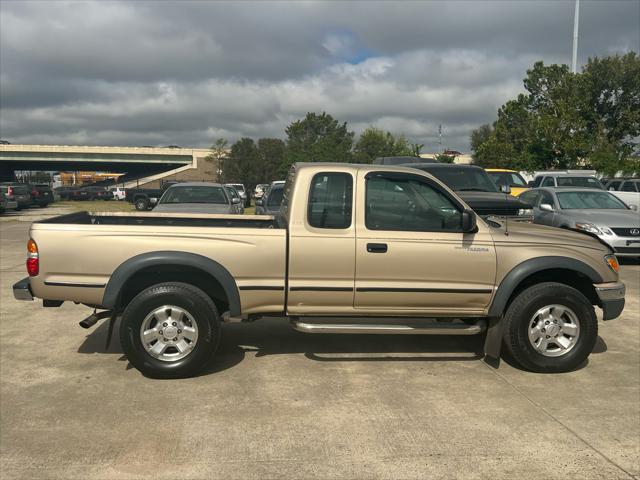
[102,251,241,316]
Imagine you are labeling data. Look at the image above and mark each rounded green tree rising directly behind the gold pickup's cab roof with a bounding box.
[281,112,354,173]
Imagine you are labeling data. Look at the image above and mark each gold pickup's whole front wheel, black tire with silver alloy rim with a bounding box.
[503,282,598,373]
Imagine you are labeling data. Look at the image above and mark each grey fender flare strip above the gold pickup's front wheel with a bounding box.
[489,257,602,317]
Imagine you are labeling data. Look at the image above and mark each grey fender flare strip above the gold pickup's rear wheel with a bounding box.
[102,251,241,316]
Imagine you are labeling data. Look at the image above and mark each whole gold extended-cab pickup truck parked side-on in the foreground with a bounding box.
[13,163,625,378]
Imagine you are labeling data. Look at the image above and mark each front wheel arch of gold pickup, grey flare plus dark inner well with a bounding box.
[488,256,603,317]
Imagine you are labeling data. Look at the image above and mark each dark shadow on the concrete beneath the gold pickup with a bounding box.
[78,318,607,376]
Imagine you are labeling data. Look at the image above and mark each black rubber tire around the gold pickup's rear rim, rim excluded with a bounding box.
[120,282,221,378]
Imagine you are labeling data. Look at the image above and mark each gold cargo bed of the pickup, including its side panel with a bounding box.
[30,212,287,313]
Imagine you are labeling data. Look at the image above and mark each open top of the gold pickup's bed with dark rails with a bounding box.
[36,212,285,228]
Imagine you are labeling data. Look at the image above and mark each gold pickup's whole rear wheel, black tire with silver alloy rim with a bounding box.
[120,282,220,378]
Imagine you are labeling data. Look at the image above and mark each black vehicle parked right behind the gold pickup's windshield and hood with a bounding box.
[405,163,531,220]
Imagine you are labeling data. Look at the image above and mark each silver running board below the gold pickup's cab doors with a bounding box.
[291,320,487,335]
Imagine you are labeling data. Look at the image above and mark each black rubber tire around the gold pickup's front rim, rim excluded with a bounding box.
[503,282,598,373]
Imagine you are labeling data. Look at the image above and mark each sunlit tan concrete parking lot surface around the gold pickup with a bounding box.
[0,221,640,479]
